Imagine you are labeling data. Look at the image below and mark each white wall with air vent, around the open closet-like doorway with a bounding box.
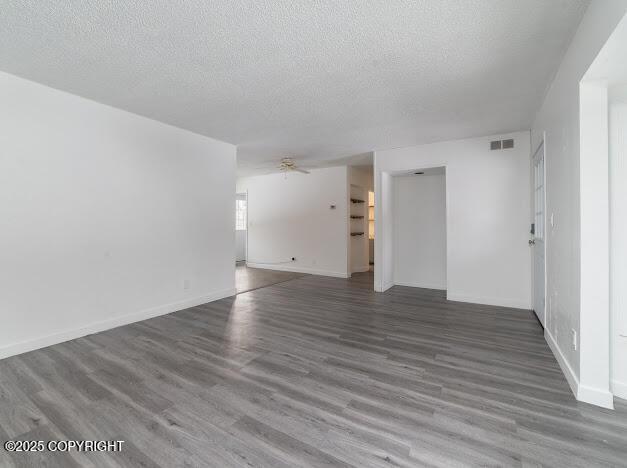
[375,132,531,309]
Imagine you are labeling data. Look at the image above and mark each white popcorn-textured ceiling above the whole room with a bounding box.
[0,0,588,174]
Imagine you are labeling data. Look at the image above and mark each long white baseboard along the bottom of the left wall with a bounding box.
[0,288,237,359]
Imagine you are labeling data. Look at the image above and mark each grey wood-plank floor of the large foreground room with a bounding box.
[0,273,627,467]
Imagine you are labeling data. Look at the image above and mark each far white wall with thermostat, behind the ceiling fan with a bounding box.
[237,166,349,277]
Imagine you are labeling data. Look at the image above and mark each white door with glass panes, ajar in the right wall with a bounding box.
[529,142,546,327]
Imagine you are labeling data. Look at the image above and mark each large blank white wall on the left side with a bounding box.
[0,73,235,357]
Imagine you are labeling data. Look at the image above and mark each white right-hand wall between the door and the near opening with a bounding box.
[532,0,627,403]
